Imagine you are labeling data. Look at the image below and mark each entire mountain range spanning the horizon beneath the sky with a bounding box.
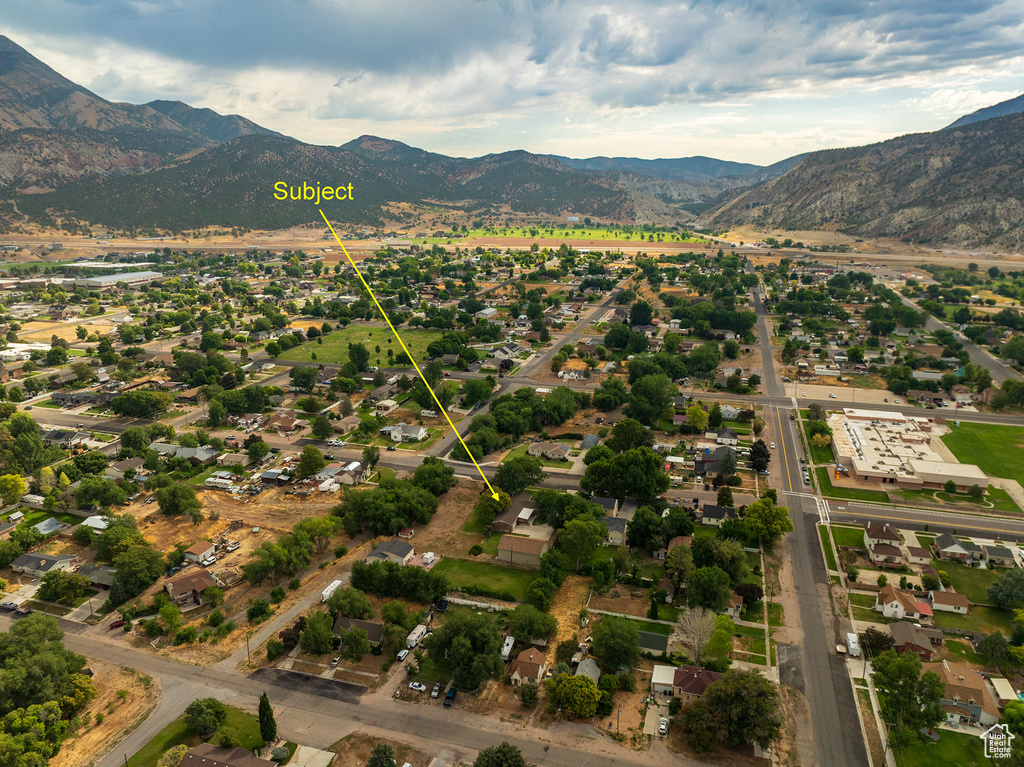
[0,36,1024,247]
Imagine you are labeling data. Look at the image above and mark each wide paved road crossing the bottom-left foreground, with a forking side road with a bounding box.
[0,616,699,767]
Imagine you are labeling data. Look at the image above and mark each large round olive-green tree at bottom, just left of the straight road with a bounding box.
[701,671,786,749]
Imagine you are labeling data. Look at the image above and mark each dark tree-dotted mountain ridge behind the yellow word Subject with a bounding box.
[18,135,678,231]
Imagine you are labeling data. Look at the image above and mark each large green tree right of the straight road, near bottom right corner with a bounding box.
[871,650,945,744]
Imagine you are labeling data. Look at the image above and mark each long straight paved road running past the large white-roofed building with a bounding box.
[754,291,868,767]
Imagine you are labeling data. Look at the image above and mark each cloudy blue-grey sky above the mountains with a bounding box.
[0,0,1024,165]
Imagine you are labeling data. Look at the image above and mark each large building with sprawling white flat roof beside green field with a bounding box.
[828,408,989,492]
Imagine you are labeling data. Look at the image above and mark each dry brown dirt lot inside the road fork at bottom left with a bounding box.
[50,661,160,767]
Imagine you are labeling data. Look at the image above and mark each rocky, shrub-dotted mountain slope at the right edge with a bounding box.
[701,115,1024,248]
